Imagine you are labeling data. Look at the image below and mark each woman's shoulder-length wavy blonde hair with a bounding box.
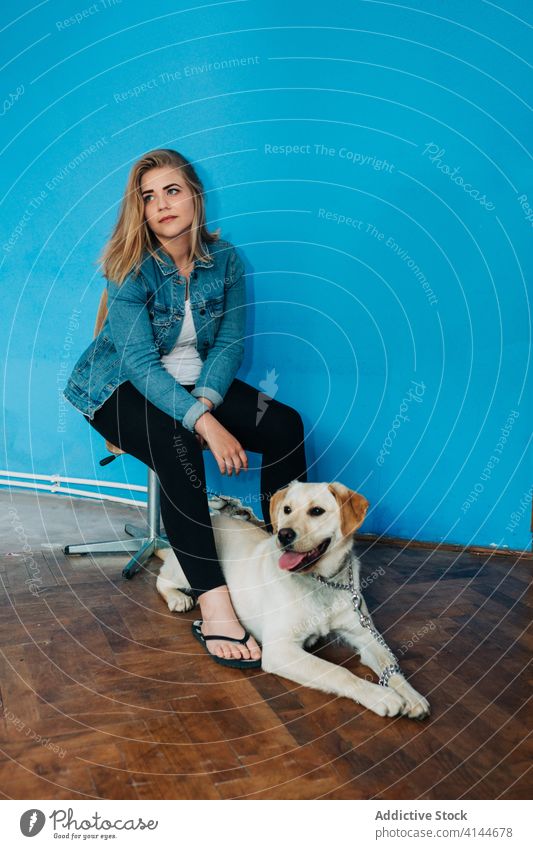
[98,148,220,284]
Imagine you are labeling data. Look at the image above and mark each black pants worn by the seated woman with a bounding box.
[83,378,307,594]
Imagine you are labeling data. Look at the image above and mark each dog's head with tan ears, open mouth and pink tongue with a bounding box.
[270,481,369,577]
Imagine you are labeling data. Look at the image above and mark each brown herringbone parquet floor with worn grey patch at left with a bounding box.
[0,486,533,799]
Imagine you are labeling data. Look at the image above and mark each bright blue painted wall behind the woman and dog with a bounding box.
[0,0,533,549]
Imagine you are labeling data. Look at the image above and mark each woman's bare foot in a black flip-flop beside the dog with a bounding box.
[198,584,261,660]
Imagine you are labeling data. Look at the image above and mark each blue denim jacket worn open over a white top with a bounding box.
[63,239,246,432]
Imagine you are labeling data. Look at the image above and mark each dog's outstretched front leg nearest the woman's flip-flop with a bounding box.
[261,639,405,716]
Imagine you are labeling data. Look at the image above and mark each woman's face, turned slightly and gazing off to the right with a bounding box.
[141,166,194,242]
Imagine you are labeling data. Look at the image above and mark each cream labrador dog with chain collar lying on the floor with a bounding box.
[156,481,430,719]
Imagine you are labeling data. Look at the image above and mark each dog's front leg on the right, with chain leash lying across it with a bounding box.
[339,612,430,719]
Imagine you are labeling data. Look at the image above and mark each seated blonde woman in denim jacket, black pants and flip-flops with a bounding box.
[64,149,307,667]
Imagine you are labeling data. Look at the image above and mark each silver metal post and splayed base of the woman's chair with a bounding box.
[63,468,170,579]
